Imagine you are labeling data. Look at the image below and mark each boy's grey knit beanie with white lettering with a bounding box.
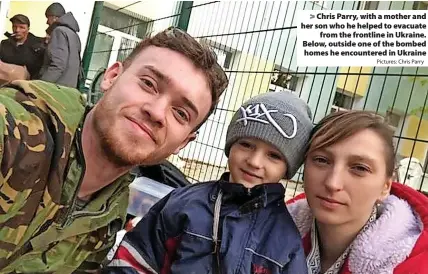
[225,91,313,179]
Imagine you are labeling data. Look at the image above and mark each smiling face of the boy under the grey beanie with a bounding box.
[228,138,287,188]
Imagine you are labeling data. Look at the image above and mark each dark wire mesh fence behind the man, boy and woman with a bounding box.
[86,1,428,196]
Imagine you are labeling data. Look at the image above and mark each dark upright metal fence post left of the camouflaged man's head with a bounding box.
[79,1,104,92]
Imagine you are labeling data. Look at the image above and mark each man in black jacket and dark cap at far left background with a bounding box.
[0,14,45,79]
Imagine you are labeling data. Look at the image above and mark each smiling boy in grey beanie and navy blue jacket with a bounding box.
[101,92,312,274]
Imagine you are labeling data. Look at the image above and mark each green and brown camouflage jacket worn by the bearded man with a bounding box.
[0,81,131,274]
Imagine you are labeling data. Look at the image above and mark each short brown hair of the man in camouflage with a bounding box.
[123,27,229,131]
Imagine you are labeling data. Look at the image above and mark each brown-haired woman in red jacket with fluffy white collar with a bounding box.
[287,110,428,274]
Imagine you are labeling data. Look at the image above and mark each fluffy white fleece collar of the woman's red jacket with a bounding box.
[287,195,423,274]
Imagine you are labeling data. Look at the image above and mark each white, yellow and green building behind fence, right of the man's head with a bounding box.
[180,1,428,186]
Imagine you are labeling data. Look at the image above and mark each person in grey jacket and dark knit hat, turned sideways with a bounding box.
[40,3,81,88]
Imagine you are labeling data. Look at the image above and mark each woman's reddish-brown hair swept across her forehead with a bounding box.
[308,110,395,177]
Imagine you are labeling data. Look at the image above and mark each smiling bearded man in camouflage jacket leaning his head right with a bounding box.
[0,26,227,273]
